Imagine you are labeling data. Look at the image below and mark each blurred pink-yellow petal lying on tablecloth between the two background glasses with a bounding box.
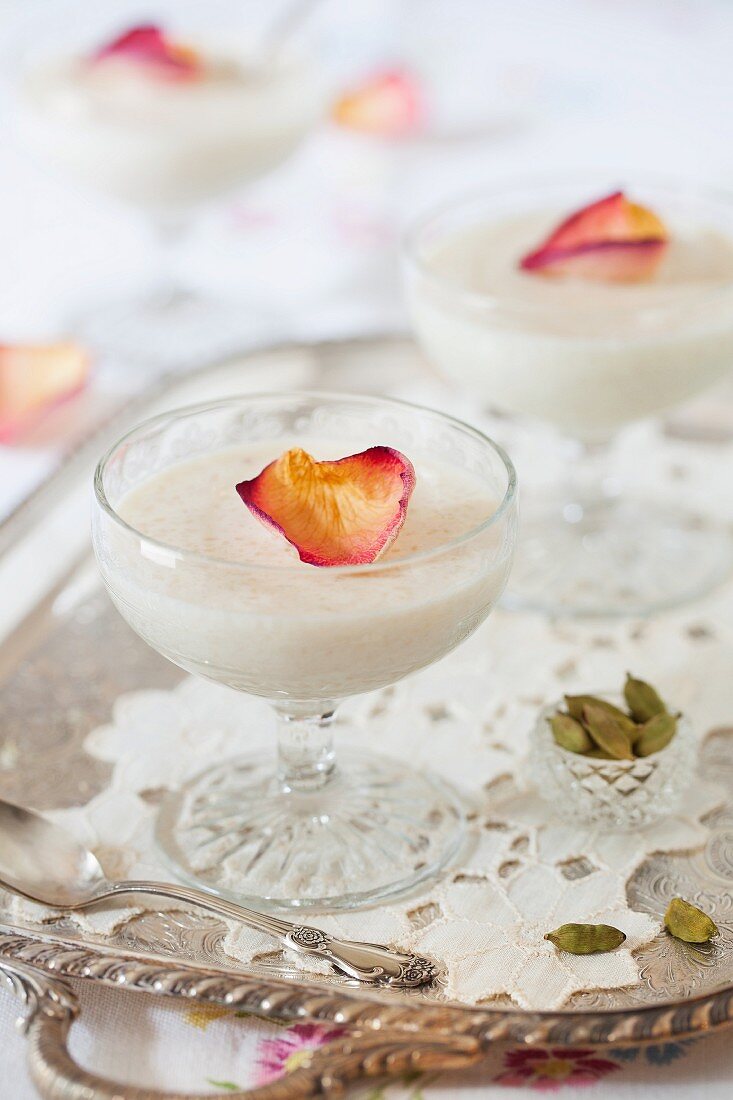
[332,70,423,138]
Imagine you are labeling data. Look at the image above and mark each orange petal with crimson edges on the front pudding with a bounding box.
[237,447,415,565]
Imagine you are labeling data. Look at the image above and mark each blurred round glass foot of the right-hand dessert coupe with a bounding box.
[503,501,733,616]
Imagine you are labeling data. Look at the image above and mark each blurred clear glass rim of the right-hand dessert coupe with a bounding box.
[402,168,733,321]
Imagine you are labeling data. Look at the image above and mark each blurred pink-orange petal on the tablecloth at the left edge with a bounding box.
[0,343,90,443]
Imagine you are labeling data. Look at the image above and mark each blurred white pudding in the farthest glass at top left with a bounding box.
[23,52,321,209]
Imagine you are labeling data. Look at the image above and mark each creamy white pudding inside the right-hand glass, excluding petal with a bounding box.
[408,211,733,440]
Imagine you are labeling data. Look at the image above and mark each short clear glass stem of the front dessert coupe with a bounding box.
[275,703,336,792]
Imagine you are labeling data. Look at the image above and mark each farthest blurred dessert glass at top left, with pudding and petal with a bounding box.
[21,24,321,359]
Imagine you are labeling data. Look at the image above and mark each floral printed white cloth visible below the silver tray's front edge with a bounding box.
[0,981,713,1100]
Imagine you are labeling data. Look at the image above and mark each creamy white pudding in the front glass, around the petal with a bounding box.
[105,439,512,701]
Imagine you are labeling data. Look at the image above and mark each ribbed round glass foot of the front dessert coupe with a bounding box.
[157,752,463,909]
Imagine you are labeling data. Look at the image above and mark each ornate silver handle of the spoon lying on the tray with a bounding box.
[103,881,440,989]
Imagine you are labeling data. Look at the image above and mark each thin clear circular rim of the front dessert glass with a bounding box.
[94,389,517,576]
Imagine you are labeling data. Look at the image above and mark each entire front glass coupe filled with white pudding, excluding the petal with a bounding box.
[92,394,517,908]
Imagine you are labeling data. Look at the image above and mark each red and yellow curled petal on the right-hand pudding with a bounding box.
[519,191,667,283]
